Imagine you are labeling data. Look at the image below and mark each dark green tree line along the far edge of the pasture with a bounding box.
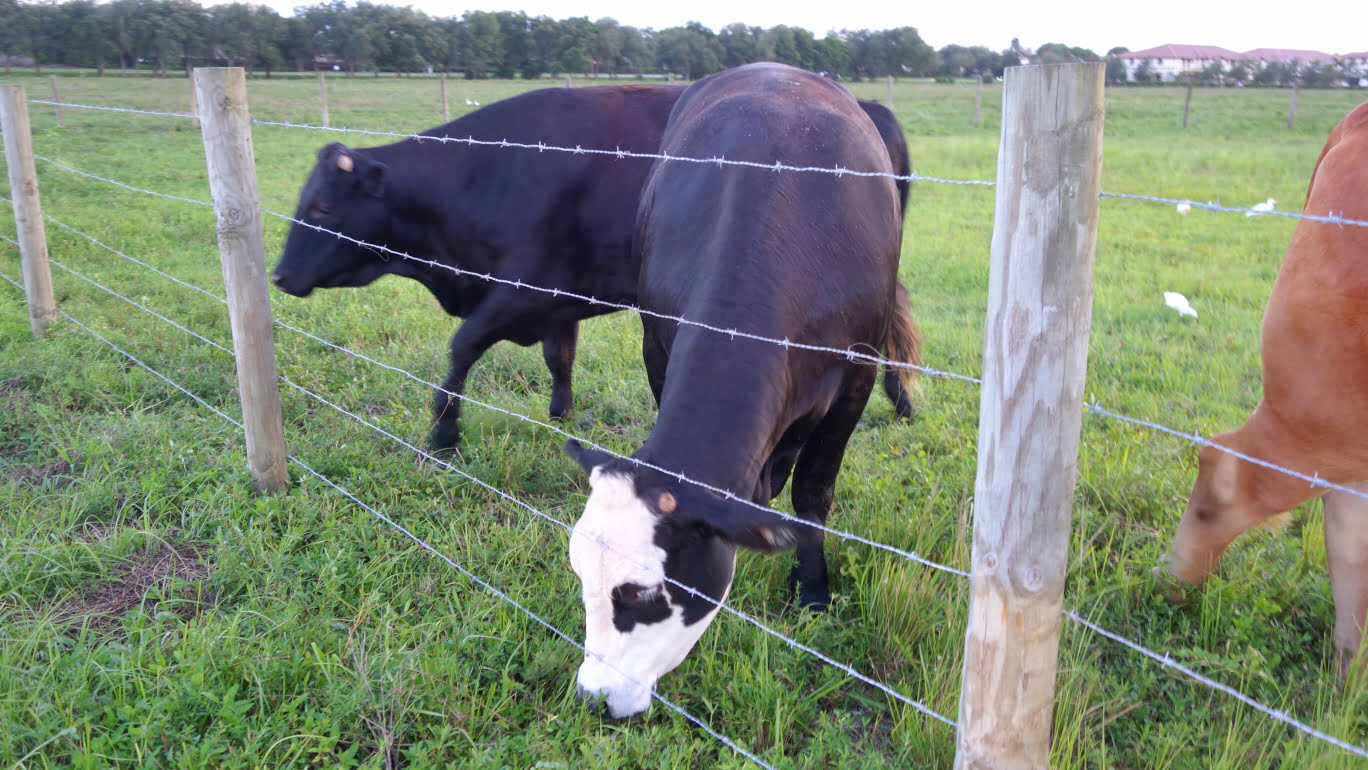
[0,0,1077,79]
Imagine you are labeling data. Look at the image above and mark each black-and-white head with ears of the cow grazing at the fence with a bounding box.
[566,440,796,719]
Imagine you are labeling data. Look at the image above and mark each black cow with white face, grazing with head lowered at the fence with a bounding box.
[566,64,912,718]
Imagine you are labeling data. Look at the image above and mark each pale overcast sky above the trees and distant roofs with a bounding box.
[232,0,1368,53]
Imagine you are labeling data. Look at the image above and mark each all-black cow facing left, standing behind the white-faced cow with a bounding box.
[271,85,915,450]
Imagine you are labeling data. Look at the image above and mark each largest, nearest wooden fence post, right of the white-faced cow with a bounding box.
[955,63,1104,770]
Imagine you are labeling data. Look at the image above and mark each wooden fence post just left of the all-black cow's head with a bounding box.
[194,67,289,494]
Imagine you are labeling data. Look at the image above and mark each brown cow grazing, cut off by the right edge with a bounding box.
[1168,97,1368,674]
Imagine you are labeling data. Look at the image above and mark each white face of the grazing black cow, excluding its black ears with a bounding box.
[570,468,736,719]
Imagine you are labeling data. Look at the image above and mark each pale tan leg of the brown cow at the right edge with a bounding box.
[1326,483,1368,681]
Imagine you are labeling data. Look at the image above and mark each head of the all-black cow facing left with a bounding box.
[271,144,398,297]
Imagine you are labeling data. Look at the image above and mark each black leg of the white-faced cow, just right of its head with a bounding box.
[788,367,876,610]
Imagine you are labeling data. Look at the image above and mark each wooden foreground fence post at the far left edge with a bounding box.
[0,86,57,336]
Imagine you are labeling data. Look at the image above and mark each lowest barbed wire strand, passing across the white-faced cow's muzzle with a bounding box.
[0,266,774,770]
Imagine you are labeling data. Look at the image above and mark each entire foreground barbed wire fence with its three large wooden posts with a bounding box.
[0,64,1368,767]
